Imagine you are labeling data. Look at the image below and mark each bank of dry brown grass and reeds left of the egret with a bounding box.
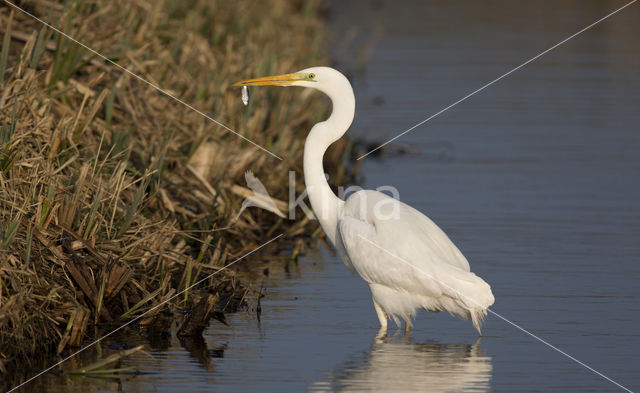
[0,0,347,369]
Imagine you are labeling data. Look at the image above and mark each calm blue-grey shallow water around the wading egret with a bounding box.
[12,1,640,392]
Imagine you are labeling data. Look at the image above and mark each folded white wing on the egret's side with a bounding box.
[339,191,493,308]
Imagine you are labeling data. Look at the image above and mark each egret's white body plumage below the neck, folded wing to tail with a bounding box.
[338,191,494,332]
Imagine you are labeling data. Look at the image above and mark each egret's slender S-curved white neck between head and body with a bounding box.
[304,87,356,246]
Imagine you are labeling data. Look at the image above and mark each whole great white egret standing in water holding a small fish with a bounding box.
[234,67,494,334]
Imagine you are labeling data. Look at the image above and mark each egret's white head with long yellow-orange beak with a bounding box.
[233,67,346,90]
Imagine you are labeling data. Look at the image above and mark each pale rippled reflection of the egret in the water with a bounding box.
[309,336,492,392]
